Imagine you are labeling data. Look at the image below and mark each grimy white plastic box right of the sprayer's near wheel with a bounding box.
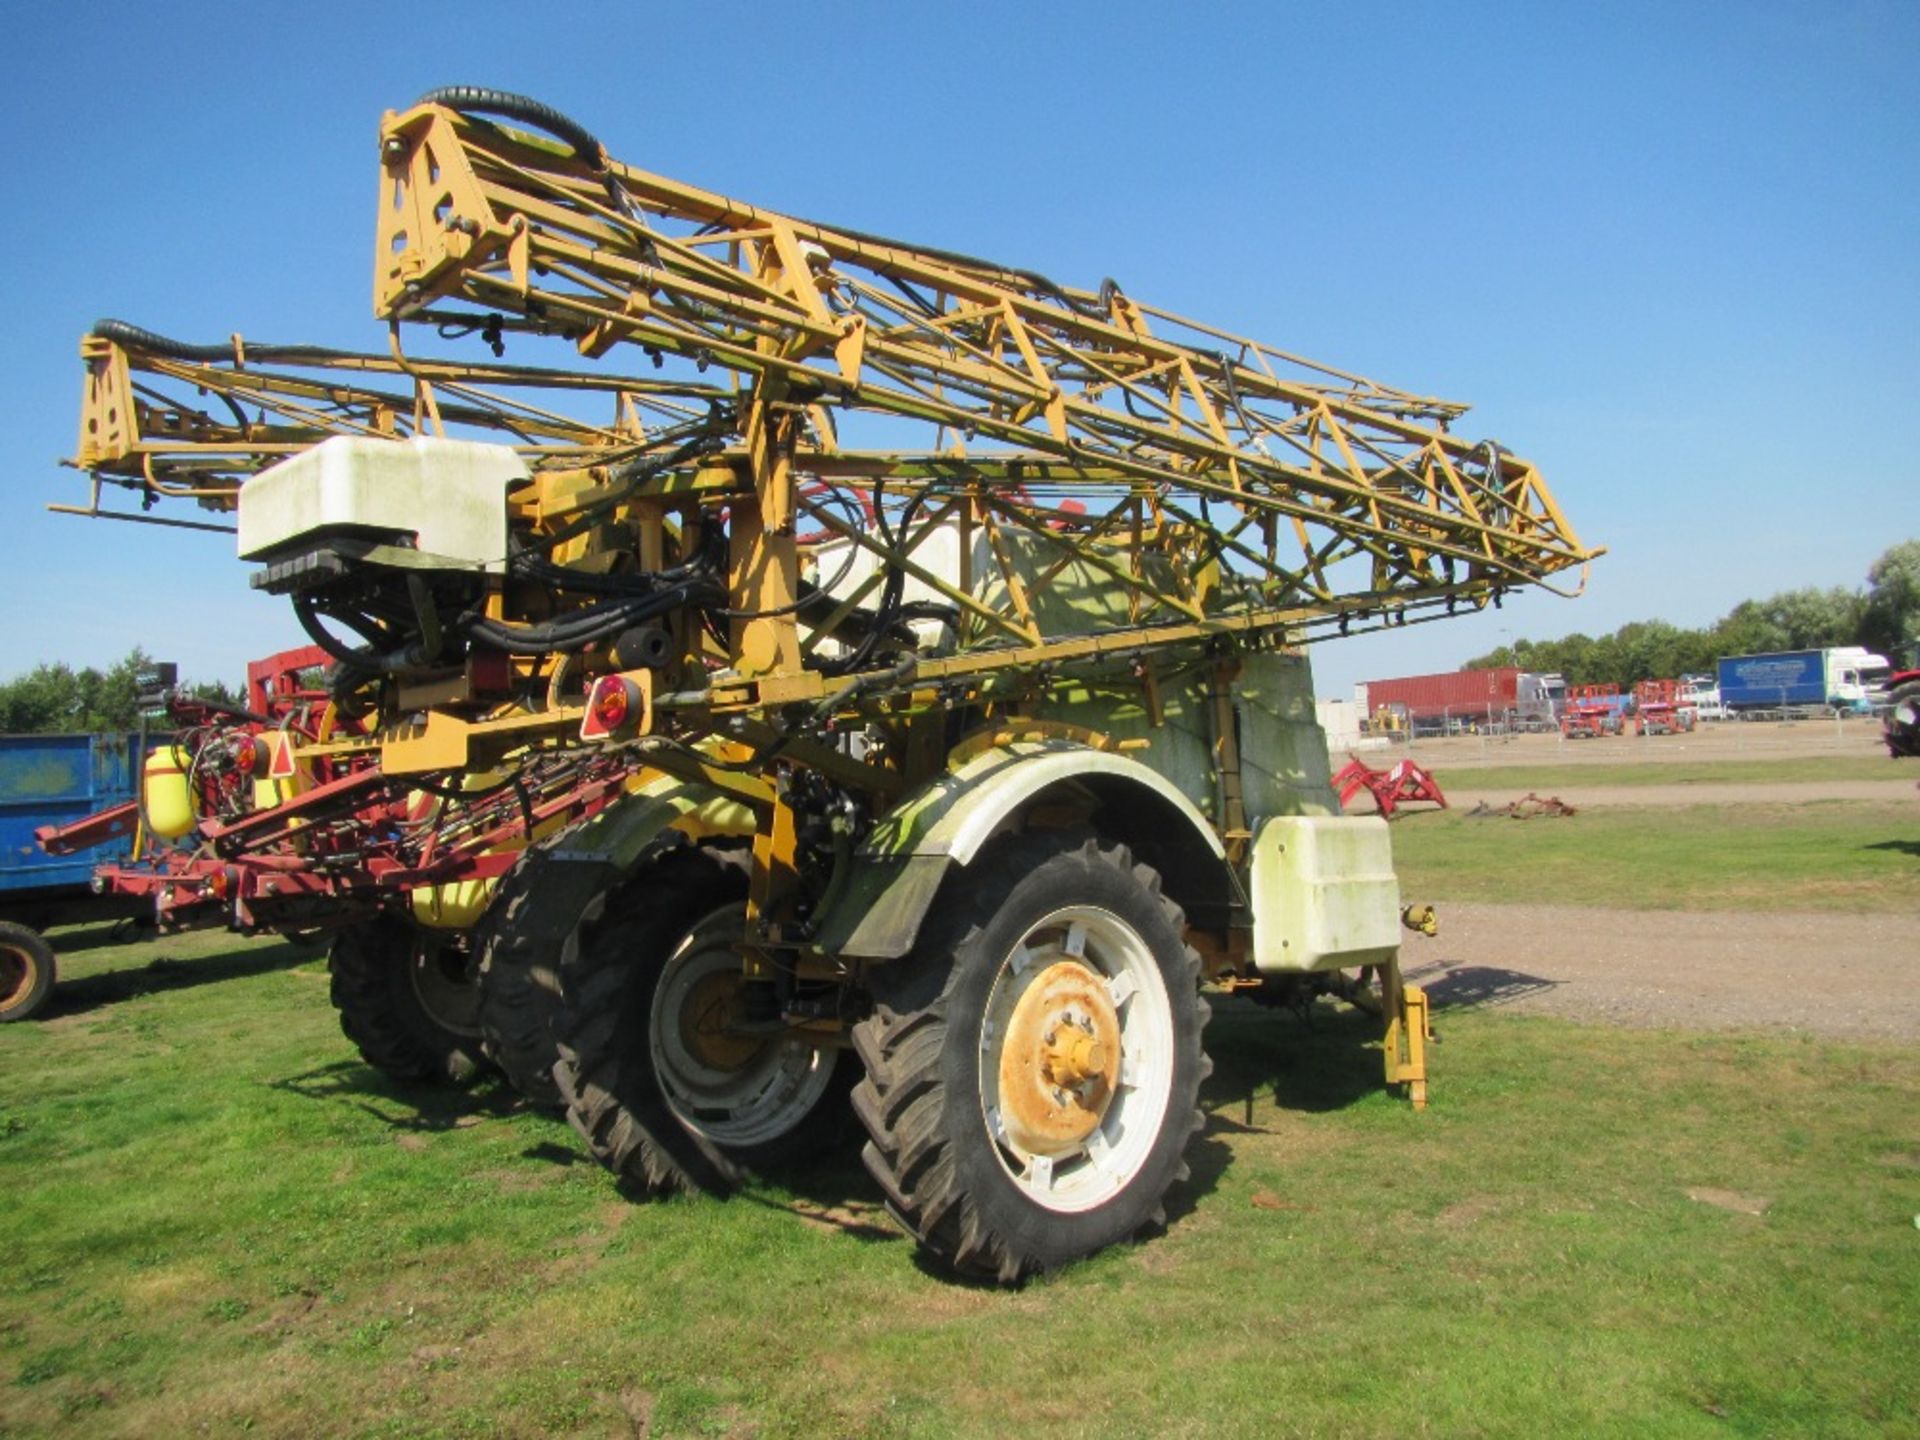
[1250,816,1400,975]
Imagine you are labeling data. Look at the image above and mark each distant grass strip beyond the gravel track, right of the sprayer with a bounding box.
[1394,801,1920,914]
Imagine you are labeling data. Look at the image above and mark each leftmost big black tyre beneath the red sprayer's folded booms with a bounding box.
[326,918,486,1085]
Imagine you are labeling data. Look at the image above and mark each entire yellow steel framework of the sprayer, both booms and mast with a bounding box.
[48,104,1601,1128]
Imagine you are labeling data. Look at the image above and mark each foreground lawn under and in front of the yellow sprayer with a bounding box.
[0,929,1920,1436]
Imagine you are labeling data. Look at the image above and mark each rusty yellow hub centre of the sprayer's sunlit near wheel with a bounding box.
[998,960,1121,1156]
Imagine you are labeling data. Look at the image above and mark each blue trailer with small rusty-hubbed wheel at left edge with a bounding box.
[0,735,163,1021]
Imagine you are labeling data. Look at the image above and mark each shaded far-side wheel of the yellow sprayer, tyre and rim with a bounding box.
[555,847,856,1192]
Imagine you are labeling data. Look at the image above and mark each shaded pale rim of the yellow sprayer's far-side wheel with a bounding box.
[647,904,833,1146]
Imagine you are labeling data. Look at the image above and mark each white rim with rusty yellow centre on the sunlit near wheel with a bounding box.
[979,906,1173,1213]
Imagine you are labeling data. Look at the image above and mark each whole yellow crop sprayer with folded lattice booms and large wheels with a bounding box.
[60,88,1596,1281]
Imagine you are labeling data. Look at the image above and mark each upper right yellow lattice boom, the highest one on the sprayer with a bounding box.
[374,92,1597,637]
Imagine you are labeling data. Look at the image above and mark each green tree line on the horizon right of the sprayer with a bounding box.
[1461,540,1920,685]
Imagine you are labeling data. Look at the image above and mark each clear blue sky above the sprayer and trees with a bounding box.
[0,0,1920,695]
